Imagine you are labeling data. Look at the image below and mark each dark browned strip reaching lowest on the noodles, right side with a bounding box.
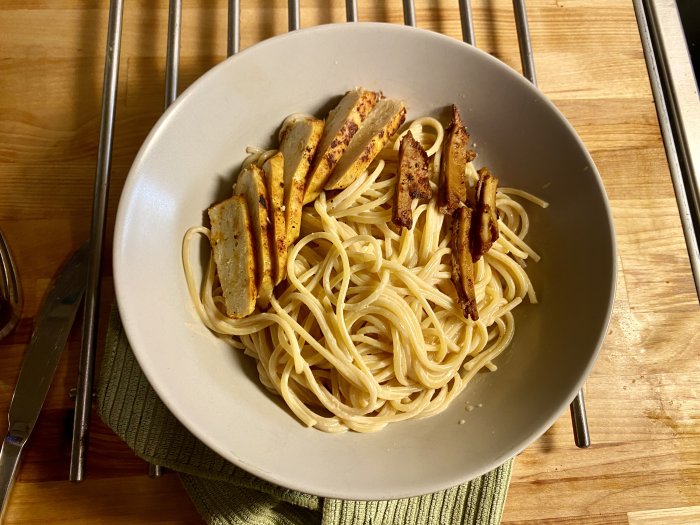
[451,206,479,321]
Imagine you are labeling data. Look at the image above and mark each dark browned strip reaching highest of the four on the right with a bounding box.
[440,104,473,215]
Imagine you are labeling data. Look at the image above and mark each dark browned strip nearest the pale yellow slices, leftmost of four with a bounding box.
[391,131,433,230]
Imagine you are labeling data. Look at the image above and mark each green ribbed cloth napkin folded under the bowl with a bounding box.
[97,308,513,525]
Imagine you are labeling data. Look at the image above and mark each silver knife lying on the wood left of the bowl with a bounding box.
[0,243,90,520]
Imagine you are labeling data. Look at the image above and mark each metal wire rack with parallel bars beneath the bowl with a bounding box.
[69,0,684,481]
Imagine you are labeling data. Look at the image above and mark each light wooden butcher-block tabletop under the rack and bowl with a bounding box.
[0,0,700,524]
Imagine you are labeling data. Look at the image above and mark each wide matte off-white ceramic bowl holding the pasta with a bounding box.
[114,23,615,499]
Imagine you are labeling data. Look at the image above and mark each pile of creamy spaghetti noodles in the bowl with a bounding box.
[182,118,539,432]
